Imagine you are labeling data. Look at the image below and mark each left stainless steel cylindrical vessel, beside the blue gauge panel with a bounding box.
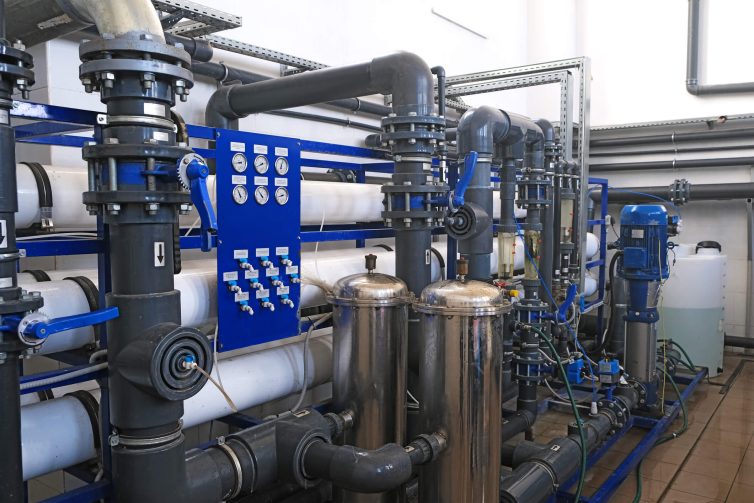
[328,266,409,503]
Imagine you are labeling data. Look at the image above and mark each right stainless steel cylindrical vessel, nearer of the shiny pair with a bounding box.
[414,280,511,503]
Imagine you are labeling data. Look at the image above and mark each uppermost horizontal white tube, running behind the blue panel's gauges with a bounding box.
[16,164,526,231]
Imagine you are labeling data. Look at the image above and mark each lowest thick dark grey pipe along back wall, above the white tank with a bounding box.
[589,182,754,204]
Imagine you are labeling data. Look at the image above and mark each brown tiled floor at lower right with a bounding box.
[524,354,754,503]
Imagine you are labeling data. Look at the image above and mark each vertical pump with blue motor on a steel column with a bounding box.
[618,204,679,407]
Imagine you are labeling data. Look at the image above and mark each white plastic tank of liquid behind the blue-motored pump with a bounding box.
[657,241,727,376]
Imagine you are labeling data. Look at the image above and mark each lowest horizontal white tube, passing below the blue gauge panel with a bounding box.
[21,335,332,480]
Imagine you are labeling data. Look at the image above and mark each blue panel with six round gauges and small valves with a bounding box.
[215,130,301,351]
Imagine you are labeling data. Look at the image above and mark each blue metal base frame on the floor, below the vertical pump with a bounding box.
[551,369,707,503]
